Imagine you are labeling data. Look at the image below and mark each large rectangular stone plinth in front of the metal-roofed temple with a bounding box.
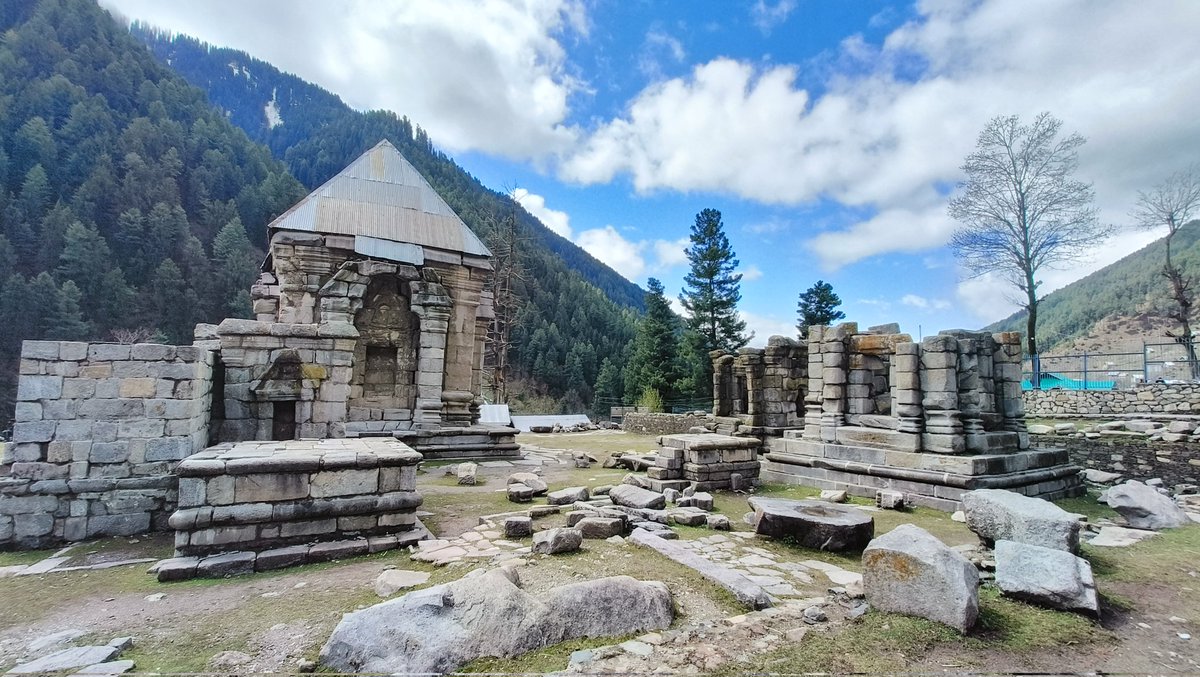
[170,438,421,556]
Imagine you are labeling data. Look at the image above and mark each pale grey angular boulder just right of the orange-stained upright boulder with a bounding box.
[995,540,1100,615]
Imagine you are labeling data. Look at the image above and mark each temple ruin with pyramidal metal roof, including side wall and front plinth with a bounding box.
[0,142,520,554]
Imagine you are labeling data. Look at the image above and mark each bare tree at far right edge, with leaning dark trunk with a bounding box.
[1133,164,1200,378]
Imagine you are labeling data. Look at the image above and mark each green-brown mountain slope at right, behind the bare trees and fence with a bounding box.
[985,221,1200,353]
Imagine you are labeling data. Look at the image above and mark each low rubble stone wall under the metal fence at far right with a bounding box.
[1022,383,1200,418]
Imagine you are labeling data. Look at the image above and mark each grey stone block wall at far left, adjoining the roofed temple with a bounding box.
[0,341,212,547]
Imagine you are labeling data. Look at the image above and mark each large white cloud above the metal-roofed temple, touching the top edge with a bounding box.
[103,0,588,158]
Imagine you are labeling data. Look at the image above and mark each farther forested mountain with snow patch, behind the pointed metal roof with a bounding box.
[131,24,644,412]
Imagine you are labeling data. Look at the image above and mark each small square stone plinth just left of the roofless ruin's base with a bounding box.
[647,435,760,491]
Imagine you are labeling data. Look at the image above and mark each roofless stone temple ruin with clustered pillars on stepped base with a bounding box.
[713,323,1084,510]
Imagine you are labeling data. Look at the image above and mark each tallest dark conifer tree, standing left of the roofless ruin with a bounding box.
[679,209,750,354]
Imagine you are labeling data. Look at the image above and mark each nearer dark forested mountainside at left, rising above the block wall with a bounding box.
[0,0,305,429]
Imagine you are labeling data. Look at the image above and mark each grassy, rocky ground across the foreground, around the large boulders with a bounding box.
[0,431,1200,673]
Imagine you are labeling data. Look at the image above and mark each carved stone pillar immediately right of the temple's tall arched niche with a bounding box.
[409,271,451,430]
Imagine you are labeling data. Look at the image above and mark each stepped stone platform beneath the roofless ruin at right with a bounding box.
[762,431,1085,511]
